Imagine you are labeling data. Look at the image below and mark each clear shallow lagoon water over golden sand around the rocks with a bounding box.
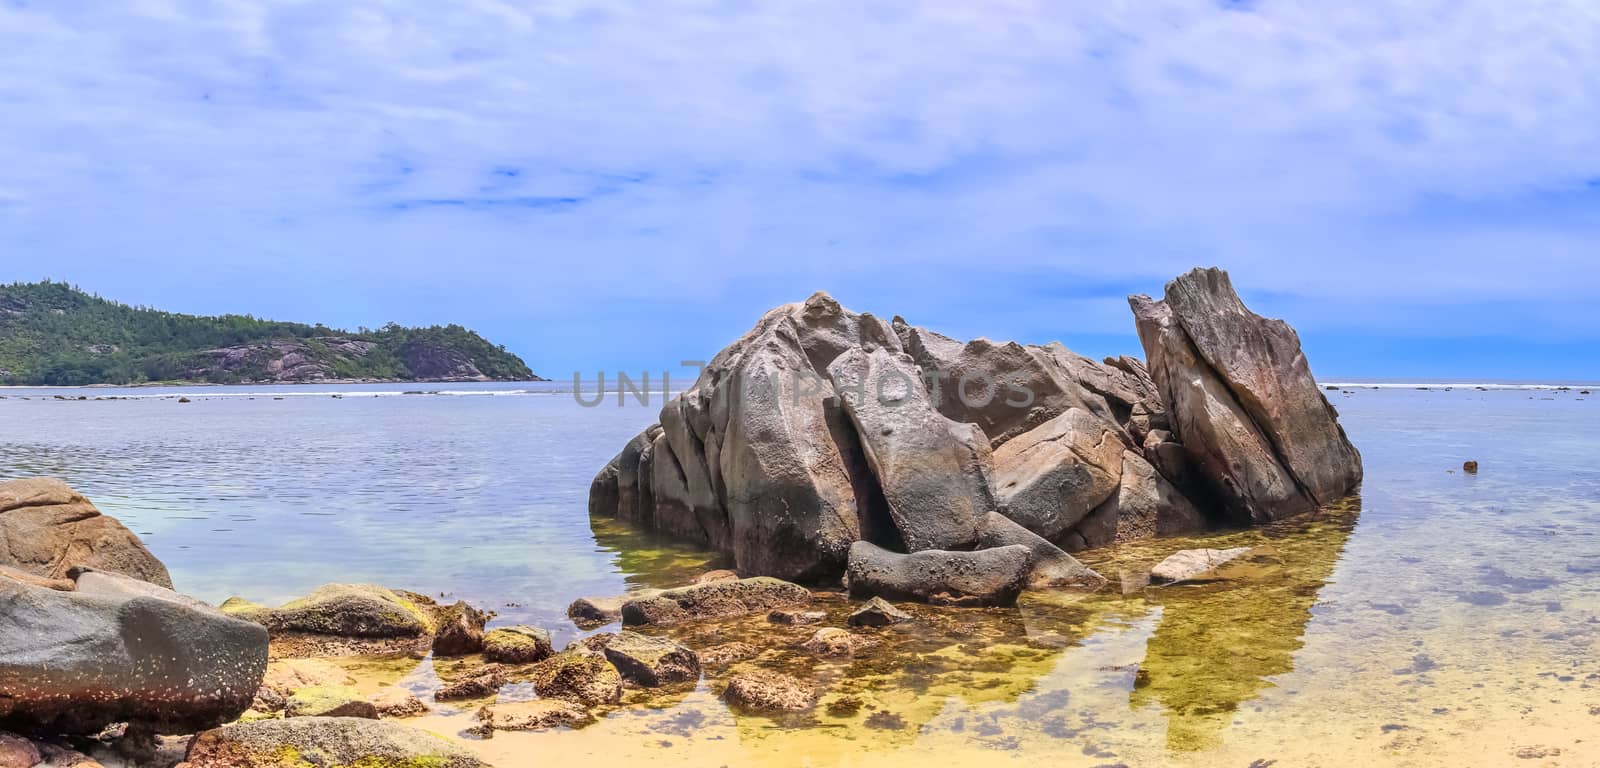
[0,384,1600,768]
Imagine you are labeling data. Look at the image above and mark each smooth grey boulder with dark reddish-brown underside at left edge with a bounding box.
[0,578,267,734]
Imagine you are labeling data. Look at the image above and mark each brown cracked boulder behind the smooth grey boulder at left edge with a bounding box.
[0,477,173,589]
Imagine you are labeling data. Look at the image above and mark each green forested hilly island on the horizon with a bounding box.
[0,282,538,386]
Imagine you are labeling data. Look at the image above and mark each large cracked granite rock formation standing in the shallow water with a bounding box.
[589,270,1362,598]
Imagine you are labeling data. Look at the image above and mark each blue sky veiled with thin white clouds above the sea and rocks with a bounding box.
[0,0,1600,379]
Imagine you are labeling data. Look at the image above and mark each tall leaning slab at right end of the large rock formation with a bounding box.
[1166,269,1362,504]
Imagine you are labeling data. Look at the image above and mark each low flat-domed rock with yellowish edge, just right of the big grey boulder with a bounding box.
[222,584,434,638]
